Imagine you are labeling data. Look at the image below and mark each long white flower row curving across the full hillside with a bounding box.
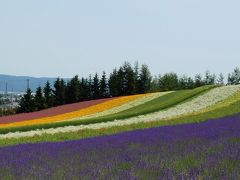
[0,85,240,139]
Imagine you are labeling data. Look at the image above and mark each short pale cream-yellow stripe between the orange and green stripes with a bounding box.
[66,91,172,121]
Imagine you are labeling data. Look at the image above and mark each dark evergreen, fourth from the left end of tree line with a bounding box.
[53,78,66,106]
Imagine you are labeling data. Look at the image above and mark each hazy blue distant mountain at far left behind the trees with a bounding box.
[0,74,61,92]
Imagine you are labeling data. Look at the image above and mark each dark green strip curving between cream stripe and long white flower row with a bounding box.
[0,86,215,134]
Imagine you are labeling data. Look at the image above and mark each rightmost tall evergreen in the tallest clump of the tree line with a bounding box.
[138,64,152,94]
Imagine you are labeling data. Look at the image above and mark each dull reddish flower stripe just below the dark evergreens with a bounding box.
[0,97,116,124]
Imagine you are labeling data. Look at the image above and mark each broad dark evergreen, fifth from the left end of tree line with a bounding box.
[66,75,81,103]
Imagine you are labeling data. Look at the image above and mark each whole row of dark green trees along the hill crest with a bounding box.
[17,62,240,113]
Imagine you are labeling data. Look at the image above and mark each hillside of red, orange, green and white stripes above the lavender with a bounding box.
[0,85,240,139]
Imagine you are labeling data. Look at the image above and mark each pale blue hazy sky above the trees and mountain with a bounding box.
[0,0,240,78]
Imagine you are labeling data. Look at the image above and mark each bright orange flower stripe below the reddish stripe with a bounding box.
[0,94,145,128]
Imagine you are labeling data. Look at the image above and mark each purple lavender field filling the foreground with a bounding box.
[0,115,240,179]
